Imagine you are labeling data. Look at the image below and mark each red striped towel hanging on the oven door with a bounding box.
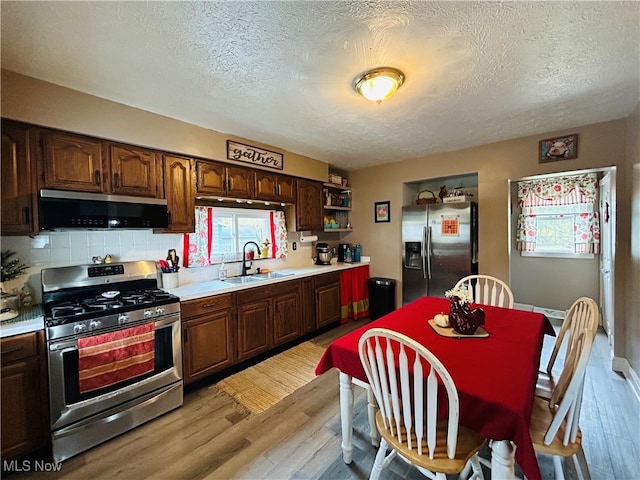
[78,322,155,393]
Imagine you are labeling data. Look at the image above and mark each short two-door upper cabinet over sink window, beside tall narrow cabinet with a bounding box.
[196,160,255,199]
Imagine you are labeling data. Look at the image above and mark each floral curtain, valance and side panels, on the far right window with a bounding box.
[516,173,600,254]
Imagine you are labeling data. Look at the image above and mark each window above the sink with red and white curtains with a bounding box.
[183,206,288,267]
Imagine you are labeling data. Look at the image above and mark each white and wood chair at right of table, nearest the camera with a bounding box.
[529,329,594,480]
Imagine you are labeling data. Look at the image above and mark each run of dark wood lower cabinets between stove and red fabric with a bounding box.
[182,273,340,384]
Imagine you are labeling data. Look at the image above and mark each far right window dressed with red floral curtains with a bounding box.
[516,174,600,257]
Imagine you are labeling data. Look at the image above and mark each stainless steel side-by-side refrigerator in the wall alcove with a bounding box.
[402,202,478,304]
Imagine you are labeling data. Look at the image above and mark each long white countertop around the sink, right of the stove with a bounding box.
[165,262,369,302]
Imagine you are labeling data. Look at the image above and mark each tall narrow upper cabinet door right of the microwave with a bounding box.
[164,155,195,233]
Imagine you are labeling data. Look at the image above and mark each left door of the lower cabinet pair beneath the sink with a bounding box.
[238,300,272,361]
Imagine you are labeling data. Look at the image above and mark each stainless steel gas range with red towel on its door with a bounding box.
[42,261,183,462]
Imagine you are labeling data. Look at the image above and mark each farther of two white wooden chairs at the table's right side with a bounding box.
[536,297,599,399]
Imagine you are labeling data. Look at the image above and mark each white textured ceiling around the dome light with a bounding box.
[1,1,640,170]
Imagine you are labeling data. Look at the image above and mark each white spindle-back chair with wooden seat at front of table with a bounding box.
[359,328,486,480]
